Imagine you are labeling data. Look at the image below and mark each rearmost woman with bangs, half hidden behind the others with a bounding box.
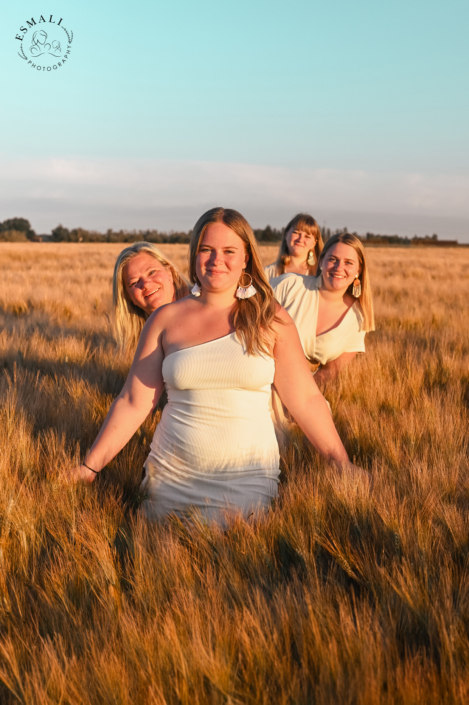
[264,213,324,281]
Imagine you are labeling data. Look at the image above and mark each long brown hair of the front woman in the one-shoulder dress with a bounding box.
[189,208,277,355]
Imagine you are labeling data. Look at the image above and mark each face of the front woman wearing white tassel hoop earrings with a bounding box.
[196,223,249,292]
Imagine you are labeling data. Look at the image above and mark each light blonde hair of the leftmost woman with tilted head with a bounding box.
[112,242,189,352]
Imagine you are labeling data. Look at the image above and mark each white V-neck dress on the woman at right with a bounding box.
[270,274,365,365]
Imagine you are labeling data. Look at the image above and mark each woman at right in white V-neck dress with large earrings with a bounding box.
[271,233,375,382]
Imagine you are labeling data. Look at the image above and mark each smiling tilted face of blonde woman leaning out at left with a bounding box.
[122,252,176,314]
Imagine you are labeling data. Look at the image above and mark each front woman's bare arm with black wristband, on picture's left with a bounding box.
[71,314,164,482]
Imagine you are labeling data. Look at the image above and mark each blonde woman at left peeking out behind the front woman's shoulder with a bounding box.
[112,242,189,352]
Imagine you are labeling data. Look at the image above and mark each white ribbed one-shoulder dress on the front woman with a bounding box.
[141,333,279,524]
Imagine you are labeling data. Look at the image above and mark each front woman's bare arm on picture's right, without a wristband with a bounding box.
[268,309,350,465]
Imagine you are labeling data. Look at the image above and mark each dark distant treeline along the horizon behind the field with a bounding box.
[0,218,459,247]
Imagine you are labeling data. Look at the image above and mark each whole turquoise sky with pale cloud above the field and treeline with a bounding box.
[0,0,469,242]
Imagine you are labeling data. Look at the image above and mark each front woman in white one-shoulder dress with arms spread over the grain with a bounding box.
[73,208,361,524]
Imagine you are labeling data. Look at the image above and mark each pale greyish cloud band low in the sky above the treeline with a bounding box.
[0,159,469,236]
